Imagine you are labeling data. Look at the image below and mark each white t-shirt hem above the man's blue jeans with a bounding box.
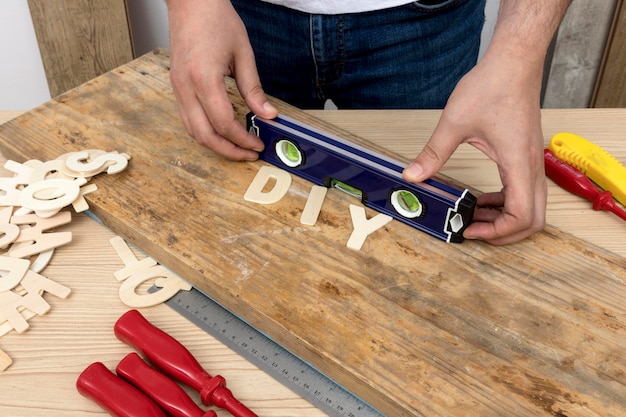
[263,0,413,14]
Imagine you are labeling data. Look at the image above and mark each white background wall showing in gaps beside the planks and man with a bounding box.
[0,0,500,110]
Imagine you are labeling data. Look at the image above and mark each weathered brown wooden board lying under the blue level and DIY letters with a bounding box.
[0,50,626,417]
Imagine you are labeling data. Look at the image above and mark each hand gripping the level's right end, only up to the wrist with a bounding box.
[405,54,546,244]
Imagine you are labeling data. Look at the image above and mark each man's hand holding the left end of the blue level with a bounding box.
[168,0,278,160]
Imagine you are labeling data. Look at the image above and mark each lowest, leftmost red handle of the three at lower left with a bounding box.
[76,362,166,417]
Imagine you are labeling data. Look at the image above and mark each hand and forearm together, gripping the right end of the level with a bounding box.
[404,0,570,244]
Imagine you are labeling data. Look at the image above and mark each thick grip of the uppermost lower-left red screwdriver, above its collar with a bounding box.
[113,310,218,392]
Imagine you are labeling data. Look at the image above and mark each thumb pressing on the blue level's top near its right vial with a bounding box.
[402,125,458,183]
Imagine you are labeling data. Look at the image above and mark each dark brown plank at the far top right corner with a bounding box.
[592,0,626,107]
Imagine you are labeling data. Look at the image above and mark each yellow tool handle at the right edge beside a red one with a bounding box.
[548,132,626,205]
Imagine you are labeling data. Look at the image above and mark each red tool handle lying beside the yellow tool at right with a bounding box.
[543,149,626,220]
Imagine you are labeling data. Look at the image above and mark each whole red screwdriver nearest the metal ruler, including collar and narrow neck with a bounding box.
[114,310,258,417]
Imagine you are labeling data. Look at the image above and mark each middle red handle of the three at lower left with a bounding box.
[116,352,217,417]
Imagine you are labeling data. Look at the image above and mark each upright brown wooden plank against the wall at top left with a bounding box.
[28,0,133,97]
